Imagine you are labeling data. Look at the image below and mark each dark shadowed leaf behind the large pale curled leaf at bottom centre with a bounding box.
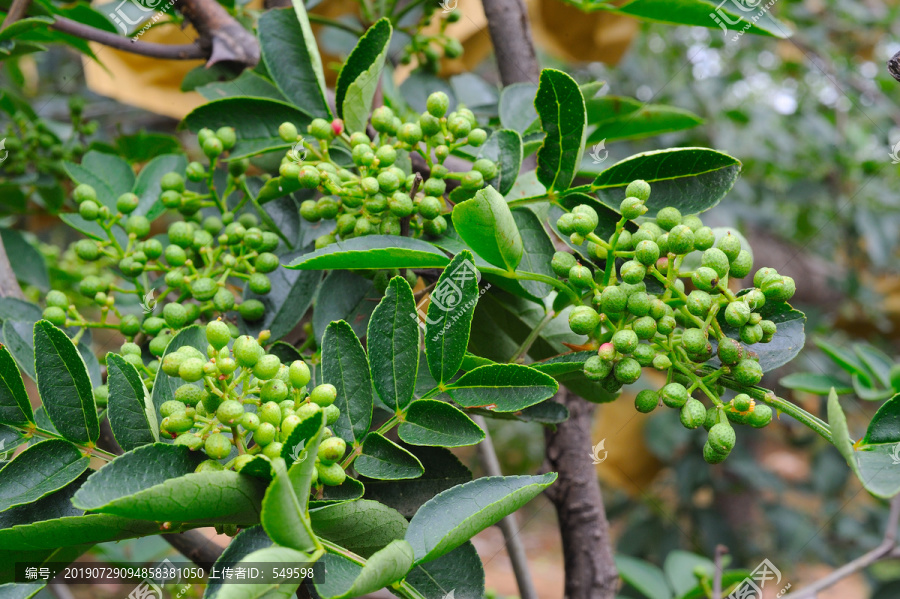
[358,446,472,518]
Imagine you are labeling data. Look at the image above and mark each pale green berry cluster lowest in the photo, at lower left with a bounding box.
[158,320,347,486]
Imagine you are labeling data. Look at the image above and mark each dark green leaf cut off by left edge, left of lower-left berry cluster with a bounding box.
[0,439,90,512]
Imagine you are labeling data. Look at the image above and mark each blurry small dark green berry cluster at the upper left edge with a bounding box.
[0,96,97,180]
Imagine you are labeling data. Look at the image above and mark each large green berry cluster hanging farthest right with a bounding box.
[552,181,796,463]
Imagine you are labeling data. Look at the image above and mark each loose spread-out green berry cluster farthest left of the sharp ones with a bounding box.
[43,127,280,356]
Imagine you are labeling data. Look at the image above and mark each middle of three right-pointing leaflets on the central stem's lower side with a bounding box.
[397,399,484,447]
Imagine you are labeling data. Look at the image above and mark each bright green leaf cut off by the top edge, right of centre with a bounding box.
[612,0,790,41]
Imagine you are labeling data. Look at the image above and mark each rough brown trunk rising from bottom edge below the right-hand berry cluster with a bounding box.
[544,388,619,599]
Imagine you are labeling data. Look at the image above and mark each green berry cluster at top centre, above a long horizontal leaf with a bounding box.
[278,92,498,247]
